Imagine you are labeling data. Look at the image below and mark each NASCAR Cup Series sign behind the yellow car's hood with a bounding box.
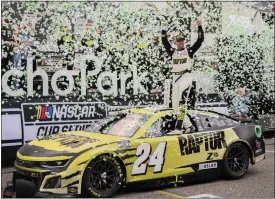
[21,102,107,143]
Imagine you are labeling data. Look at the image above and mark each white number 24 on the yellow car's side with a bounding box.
[132,142,166,175]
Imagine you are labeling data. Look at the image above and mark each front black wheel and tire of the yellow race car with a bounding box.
[82,155,124,198]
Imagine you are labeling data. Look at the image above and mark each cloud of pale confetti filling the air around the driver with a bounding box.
[2,1,274,118]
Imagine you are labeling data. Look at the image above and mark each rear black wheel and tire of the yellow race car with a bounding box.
[222,143,249,180]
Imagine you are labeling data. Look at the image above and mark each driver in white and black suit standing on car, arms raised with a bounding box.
[162,20,204,132]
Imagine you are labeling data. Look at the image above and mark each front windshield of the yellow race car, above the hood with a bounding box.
[86,113,149,137]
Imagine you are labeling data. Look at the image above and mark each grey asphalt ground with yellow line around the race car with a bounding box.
[1,138,274,198]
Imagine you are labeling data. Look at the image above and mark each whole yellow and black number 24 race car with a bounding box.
[4,108,265,197]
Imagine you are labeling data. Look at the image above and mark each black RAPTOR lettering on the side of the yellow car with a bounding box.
[178,131,227,155]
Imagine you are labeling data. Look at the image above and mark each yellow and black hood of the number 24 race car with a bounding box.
[18,131,129,157]
